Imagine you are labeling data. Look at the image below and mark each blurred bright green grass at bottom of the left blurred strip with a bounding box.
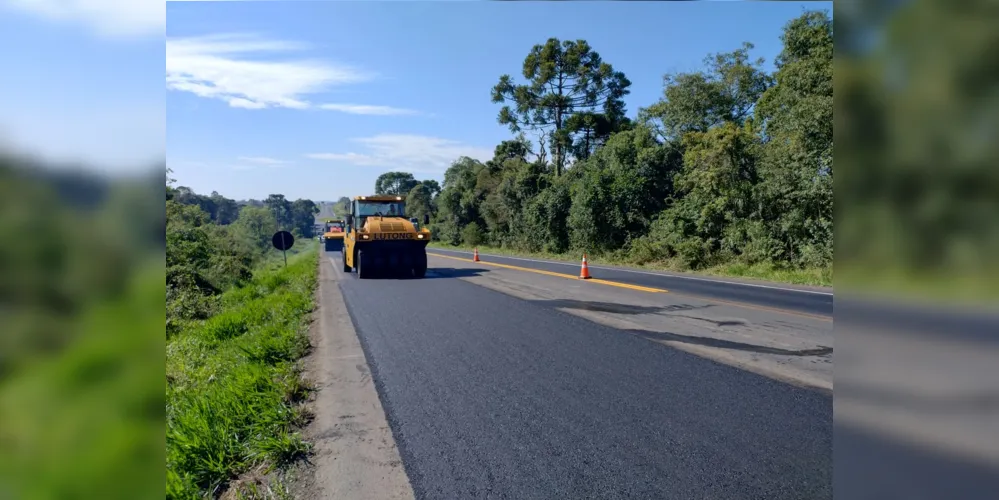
[0,255,164,500]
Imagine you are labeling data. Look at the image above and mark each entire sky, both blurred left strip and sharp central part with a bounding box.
[0,0,832,201]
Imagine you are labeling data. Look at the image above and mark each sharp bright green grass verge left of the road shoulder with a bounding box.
[166,245,318,499]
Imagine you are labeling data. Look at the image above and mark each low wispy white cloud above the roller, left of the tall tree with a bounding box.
[306,134,493,174]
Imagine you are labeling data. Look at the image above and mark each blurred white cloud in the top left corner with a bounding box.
[0,0,166,39]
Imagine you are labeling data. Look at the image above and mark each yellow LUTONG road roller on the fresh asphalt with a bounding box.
[343,195,430,279]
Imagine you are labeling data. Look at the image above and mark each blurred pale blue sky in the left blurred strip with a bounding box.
[0,0,166,172]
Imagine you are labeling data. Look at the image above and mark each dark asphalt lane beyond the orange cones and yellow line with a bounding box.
[428,248,833,316]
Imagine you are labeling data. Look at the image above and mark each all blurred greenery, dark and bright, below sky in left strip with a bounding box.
[0,161,165,500]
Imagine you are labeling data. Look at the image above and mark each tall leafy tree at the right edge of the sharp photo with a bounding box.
[756,12,833,265]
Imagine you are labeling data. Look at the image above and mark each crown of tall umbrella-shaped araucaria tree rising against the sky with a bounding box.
[492,38,631,175]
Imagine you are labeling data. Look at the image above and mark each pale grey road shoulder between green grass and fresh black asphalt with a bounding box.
[295,255,414,500]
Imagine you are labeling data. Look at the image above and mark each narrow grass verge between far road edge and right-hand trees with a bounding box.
[429,242,833,286]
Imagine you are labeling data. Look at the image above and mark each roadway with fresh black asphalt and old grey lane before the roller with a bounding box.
[325,252,832,499]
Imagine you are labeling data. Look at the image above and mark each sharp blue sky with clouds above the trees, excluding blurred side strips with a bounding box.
[167,2,831,200]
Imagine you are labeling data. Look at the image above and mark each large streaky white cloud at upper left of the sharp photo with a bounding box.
[166,34,373,109]
